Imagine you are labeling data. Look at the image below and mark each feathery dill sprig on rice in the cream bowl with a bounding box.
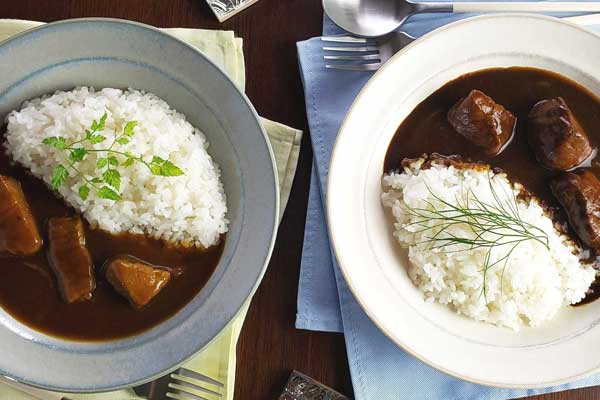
[404,178,550,303]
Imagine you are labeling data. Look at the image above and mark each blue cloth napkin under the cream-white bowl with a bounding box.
[296,9,600,400]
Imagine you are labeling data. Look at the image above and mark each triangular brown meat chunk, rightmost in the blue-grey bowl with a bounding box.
[106,256,171,308]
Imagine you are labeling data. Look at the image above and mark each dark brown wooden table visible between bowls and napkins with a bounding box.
[0,0,600,400]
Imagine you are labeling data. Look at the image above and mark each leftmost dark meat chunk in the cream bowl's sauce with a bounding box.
[447,90,517,155]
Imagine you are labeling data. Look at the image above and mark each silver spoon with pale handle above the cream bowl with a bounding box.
[323,0,600,37]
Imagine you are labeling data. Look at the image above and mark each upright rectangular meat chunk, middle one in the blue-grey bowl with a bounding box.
[48,217,96,303]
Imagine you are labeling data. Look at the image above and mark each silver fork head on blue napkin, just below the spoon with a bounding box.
[321,32,415,71]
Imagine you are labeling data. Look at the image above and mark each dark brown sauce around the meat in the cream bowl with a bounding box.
[383,67,600,304]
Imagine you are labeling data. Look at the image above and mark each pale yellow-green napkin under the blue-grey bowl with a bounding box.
[0,19,302,400]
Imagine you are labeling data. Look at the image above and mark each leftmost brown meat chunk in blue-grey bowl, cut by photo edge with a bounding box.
[0,175,42,255]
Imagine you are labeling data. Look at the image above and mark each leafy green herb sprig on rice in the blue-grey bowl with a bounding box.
[42,113,183,201]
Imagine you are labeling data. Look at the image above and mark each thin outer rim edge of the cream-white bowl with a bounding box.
[326,13,600,390]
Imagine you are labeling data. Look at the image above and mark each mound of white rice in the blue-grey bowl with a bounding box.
[6,87,228,247]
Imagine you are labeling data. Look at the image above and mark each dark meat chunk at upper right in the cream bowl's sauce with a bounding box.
[529,97,594,171]
